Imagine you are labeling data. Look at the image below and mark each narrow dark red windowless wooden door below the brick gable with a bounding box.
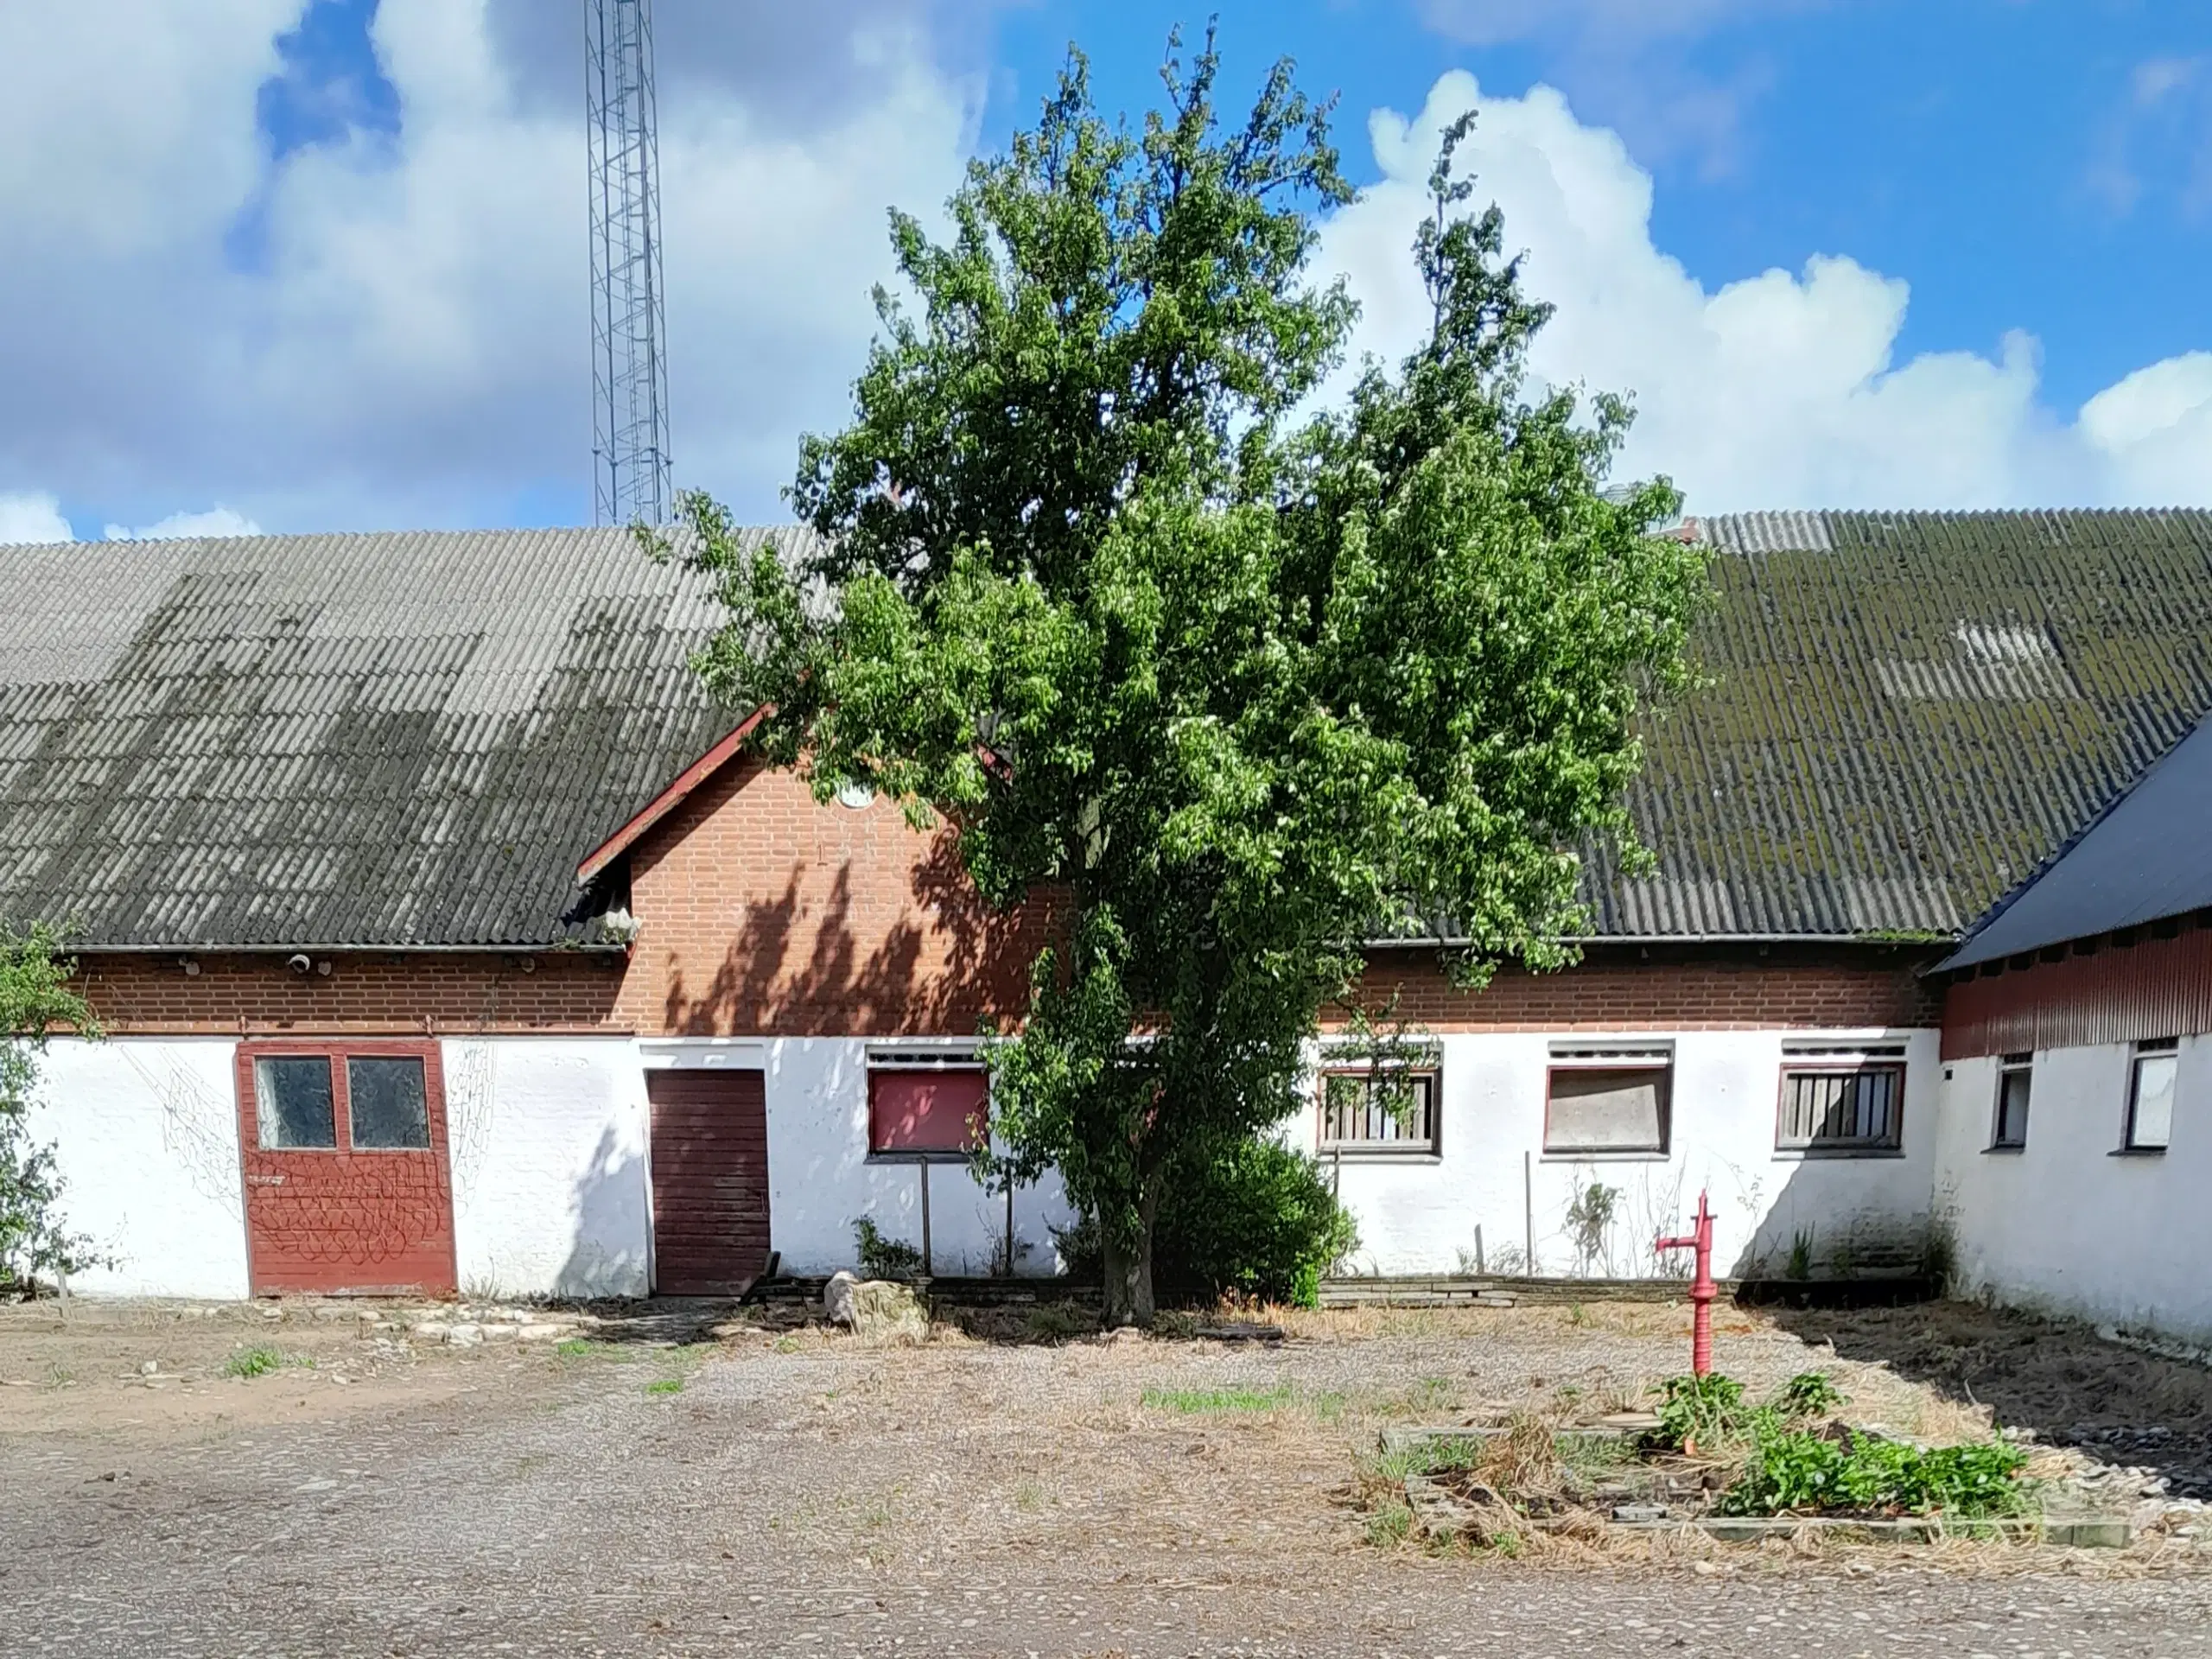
[646,1071,767,1296]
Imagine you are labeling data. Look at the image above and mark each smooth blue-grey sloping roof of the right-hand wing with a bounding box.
[1942,723,2212,969]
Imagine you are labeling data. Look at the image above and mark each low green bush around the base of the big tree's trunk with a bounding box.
[1058,1135,1360,1307]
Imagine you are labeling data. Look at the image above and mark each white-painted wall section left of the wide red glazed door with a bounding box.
[29,1038,248,1299]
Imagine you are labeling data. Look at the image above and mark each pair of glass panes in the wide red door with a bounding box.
[238,1042,438,1153]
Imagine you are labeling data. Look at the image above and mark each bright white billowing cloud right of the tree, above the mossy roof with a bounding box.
[1320,71,2212,513]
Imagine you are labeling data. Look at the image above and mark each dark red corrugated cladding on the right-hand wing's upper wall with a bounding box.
[1942,927,2212,1059]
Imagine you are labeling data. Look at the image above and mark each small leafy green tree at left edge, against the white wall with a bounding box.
[0,927,99,1294]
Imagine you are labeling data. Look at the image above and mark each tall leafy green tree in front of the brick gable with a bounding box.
[683,38,1703,1320]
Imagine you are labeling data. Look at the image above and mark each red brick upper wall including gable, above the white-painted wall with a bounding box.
[64,761,1938,1035]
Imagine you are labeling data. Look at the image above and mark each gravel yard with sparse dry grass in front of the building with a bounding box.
[0,1303,2212,1659]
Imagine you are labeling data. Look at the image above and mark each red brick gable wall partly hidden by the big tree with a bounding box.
[617,761,1051,1035]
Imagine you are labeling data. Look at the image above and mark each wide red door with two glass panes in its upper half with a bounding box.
[238,1042,455,1296]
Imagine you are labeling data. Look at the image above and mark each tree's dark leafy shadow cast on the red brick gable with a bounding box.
[664,832,1051,1038]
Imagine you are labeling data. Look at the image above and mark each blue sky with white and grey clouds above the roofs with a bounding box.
[0,0,2212,537]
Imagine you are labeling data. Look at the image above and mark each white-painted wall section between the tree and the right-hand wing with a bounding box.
[1294,1031,1940,1276]
